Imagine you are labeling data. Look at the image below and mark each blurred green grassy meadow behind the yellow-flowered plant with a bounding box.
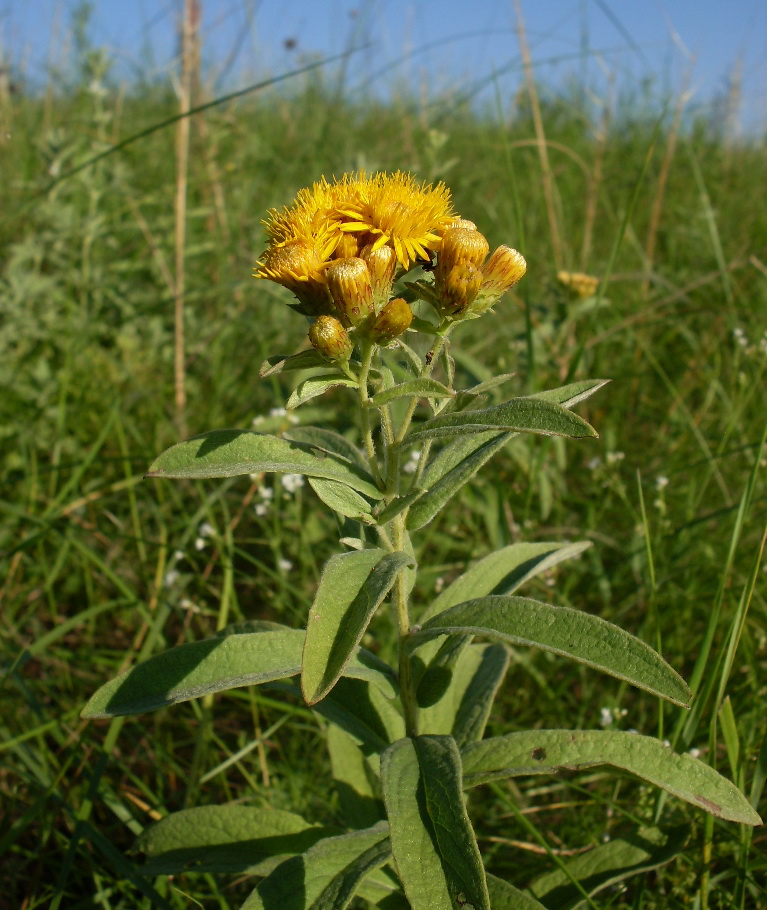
[0,1,767,910]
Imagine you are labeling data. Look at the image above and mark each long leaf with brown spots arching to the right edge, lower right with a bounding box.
[463,730,761,825]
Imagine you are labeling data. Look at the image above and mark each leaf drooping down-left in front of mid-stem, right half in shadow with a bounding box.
[301,549,411,705]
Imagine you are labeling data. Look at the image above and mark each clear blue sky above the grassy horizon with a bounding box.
[0,0,767,129]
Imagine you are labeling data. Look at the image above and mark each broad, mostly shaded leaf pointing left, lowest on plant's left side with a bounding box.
[134,805,337,875]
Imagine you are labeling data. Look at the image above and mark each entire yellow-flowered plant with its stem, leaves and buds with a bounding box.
[83,175,760,910]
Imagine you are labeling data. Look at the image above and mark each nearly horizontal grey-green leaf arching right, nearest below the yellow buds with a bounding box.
[403,398,598,446]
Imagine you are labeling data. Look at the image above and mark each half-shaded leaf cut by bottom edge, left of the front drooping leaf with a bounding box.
[241,822,391,910]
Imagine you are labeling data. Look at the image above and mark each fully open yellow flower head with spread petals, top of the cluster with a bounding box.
[338,171,455,269]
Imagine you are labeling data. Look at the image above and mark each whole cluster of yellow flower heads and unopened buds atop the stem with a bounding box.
[255,172,526,364]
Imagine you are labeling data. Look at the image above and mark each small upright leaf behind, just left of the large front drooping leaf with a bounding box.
[325,724,384,828]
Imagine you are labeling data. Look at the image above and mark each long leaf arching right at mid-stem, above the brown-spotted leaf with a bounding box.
[409,595,691,705]
